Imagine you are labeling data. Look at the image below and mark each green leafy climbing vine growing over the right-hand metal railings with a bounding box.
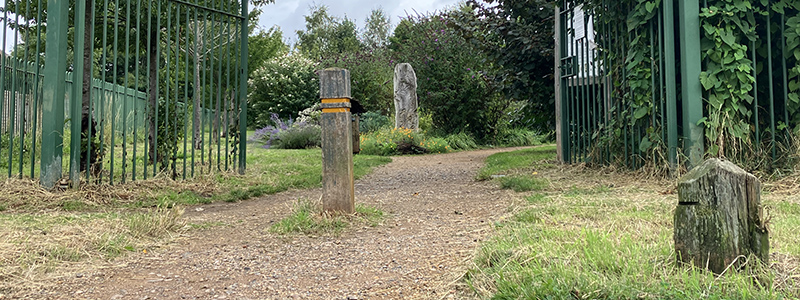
[574,0,800,170]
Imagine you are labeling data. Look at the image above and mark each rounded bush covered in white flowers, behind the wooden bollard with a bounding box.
[247,52,319,128]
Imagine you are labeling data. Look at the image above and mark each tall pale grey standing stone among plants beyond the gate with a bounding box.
[394,63,419,130]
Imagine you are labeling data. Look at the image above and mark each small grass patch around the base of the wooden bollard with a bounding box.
[269,199,384,235]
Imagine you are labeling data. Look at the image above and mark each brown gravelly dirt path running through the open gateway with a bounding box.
[29,149,514,299]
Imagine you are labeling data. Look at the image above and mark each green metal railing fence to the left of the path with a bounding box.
[0,0,248,187]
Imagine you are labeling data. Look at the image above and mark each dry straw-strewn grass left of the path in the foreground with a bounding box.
[0,207,185,292]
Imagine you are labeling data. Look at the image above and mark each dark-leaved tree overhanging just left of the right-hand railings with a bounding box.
[454,0,555,130]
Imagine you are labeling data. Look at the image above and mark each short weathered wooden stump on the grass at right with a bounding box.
[674,158,769,274]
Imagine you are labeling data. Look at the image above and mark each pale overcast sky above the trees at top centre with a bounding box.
[253,0,458,44]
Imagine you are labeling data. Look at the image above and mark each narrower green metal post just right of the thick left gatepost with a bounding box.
[70,0,86,187]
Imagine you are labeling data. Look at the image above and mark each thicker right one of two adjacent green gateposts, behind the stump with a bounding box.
[680,0,705,168]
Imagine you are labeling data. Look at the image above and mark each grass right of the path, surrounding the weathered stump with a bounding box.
[463,145,800,299]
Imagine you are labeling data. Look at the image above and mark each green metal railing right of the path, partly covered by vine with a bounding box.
[556,0,800,170]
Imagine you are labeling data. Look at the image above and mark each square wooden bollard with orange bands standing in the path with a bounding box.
[319,68,355,214]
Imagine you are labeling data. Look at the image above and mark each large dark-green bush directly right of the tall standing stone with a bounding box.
[389,11,500,143]
